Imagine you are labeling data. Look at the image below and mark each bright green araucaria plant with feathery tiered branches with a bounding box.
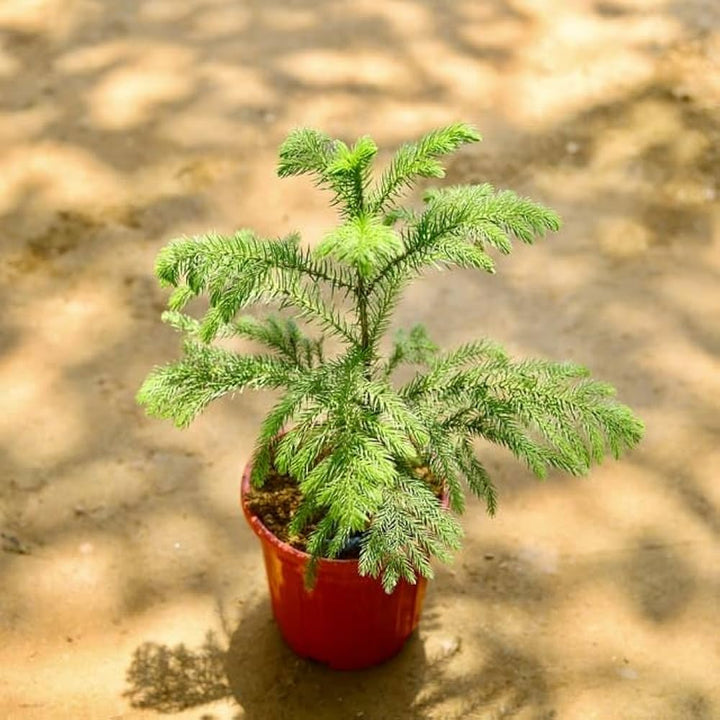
[138,124,643,591]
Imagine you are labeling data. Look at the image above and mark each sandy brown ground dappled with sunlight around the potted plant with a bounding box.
[0,0,720,720]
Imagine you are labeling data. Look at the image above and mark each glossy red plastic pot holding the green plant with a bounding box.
[241,464,427,670]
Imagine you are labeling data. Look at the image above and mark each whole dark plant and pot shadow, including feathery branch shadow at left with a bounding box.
[125,600,554,720]
